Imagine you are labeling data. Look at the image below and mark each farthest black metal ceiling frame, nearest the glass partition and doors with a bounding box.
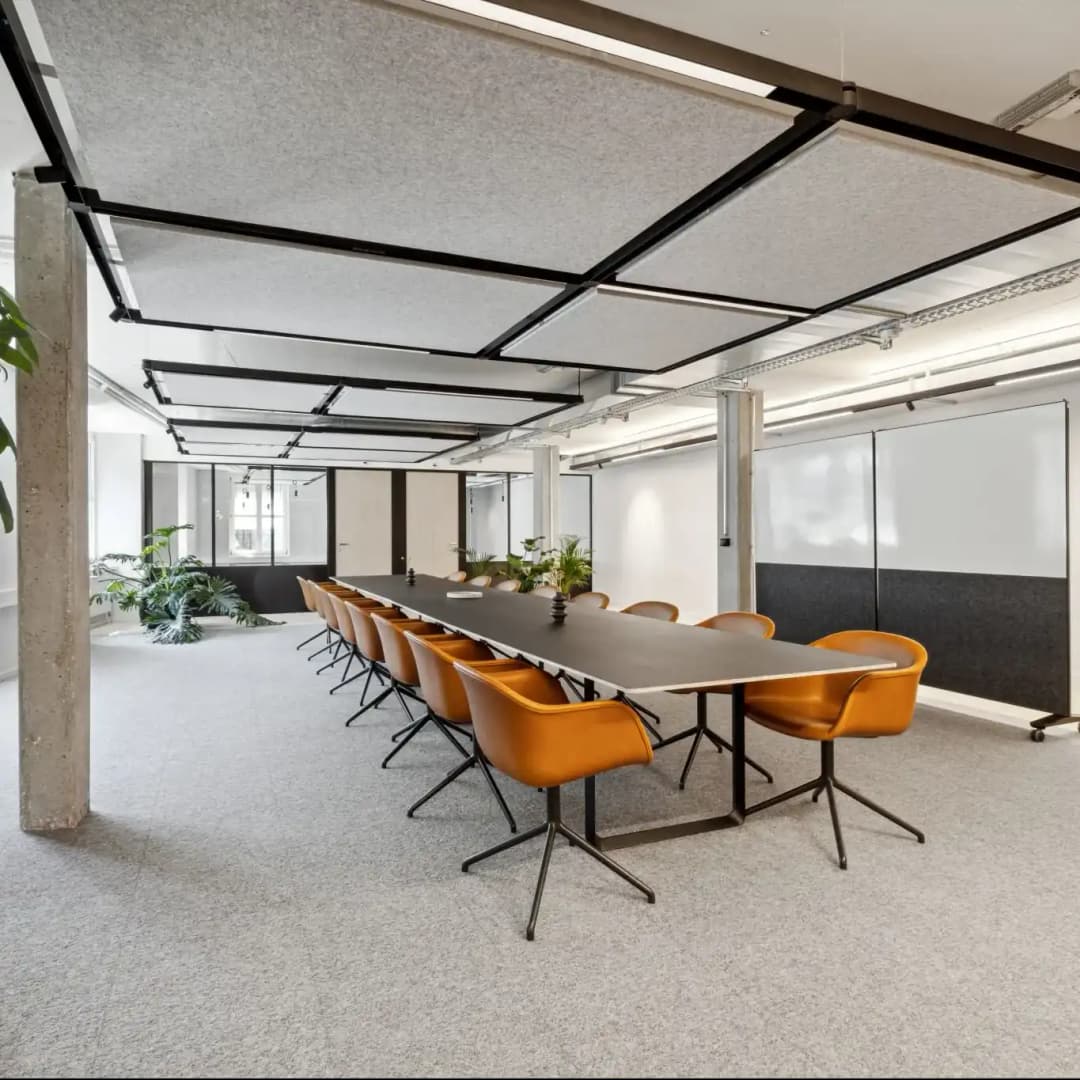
[165,414,479,464]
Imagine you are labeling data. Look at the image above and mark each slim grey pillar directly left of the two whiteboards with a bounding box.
[716,392,761,611]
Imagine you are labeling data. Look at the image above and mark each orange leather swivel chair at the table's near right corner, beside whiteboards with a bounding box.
[745,630,927,869]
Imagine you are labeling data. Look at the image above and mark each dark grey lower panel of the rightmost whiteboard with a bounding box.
[878,570,1069,713]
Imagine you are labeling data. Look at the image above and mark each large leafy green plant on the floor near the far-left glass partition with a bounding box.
[90,525,276,645]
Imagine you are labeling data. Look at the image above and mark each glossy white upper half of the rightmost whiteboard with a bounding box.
[877,402,1066,578]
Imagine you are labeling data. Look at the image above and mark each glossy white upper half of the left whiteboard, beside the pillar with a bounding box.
[754,434,874,567]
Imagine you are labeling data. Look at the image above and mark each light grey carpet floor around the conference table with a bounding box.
[0,623,1080,1076]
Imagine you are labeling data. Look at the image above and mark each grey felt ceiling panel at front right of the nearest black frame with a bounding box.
[620,130,1080,308]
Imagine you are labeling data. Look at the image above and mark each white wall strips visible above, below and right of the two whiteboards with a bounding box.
[761,379,1080,724]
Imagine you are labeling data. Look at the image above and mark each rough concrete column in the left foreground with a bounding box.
[15,176,90,831]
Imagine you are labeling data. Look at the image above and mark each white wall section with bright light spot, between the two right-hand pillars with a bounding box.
[593,445,717,622]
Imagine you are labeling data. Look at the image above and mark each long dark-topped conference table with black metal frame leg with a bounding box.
[334,573,895,850]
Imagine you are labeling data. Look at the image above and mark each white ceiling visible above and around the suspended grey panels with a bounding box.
[6,0,1080,468]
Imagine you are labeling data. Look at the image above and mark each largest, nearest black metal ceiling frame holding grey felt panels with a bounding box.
[6,0,1080,384]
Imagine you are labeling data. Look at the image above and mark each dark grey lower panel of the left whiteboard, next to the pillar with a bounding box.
[757,563,875,645]
